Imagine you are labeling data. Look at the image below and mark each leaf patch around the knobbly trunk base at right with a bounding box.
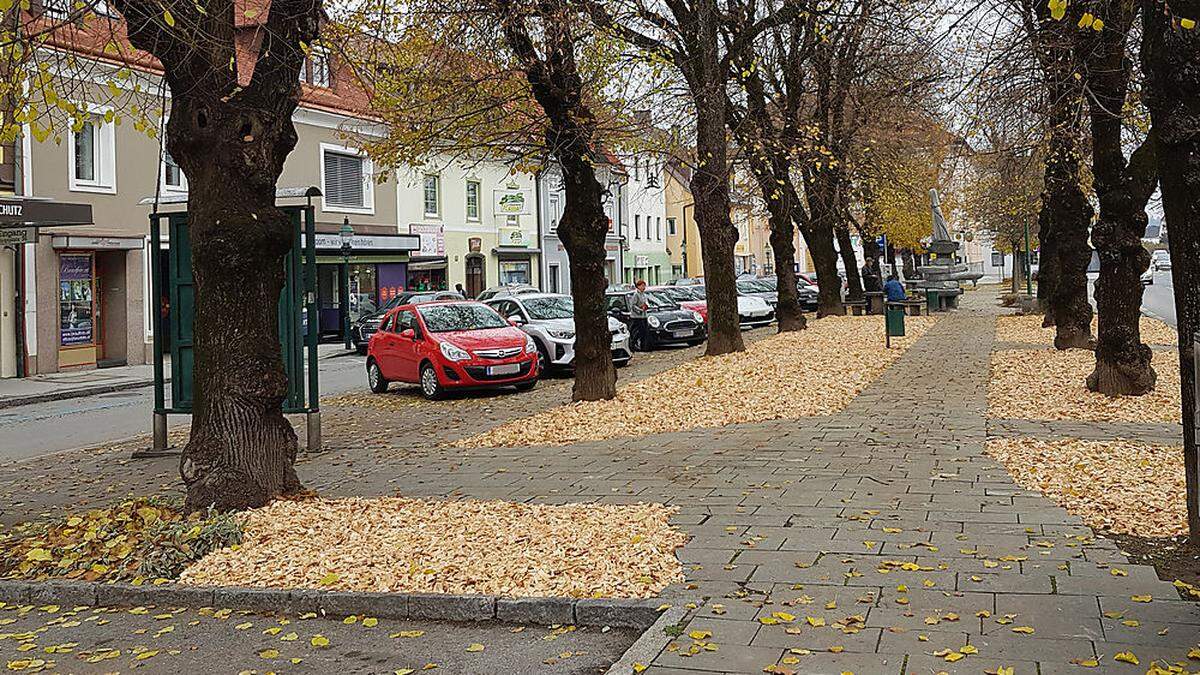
[988,350,1182,423]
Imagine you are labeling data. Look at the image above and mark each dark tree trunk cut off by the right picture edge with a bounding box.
[1141,0,1200,535]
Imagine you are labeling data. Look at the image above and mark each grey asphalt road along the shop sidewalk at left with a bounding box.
[0,356,366,462]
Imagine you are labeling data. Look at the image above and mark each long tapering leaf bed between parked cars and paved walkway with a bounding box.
[455,316,938,448]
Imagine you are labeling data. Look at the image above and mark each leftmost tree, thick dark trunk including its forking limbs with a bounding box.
[107,0,322,510]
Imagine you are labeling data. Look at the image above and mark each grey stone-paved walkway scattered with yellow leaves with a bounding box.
[0,292,1200,675]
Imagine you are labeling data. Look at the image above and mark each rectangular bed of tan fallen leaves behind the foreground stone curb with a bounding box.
[180,497,688,598]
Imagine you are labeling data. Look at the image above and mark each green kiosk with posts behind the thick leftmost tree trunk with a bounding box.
[134,187,322,458]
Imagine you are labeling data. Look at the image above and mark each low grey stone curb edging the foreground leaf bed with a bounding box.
[0,580,664,631]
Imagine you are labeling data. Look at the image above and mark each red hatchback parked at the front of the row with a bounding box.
[367,301,538,399]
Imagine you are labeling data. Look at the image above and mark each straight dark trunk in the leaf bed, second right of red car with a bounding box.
[691,90,745,357]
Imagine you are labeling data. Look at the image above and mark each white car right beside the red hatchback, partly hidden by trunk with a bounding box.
[486,293,634,371]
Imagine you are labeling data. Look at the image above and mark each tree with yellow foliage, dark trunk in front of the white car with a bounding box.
[346,0,638,400]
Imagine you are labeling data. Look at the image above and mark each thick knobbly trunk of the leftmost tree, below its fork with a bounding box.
[167,94,300,510]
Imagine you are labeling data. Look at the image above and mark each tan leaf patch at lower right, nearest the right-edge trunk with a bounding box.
[986,438,1187,537]
